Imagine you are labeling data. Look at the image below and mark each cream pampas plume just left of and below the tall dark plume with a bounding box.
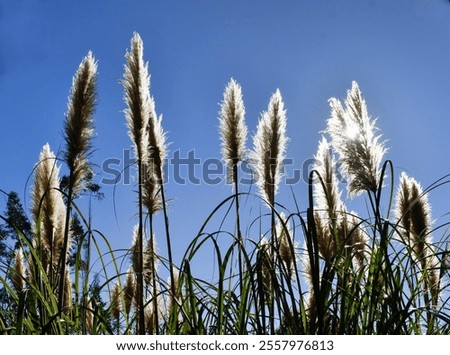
[32,144,70,268]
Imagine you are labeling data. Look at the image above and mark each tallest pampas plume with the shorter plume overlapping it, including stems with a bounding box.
[122,33,171,334]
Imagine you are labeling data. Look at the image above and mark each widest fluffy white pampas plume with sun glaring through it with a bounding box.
[327,82,386,196]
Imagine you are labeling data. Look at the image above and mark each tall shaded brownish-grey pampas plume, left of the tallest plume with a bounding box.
[64,52,97,191]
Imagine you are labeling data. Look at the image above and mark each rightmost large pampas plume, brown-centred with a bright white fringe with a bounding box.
[395,172,439,303]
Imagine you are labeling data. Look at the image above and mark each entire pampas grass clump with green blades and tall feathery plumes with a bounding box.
[0,33,450,334]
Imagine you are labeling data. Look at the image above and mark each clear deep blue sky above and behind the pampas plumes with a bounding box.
[0,0,450,276]
